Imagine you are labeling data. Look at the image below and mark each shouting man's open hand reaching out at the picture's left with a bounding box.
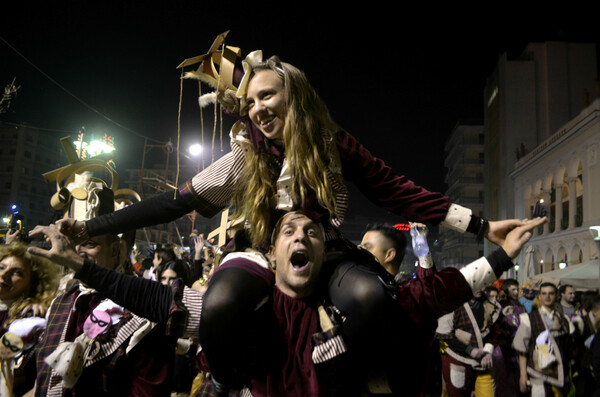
[27,225,83,272]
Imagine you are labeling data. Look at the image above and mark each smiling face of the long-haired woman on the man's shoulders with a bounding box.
[246,70,286,140]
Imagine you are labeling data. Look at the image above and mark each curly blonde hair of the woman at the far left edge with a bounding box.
[0,242,58,326]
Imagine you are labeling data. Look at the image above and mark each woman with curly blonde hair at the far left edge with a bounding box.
[0,241,58,397]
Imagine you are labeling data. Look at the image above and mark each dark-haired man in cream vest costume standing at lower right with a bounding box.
[512,282,575,396]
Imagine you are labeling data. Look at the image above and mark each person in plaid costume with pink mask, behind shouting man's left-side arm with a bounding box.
[30,179,176,397]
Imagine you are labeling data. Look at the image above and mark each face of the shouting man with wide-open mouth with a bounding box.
[269,213,325,298]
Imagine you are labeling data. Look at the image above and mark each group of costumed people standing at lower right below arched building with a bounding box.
[436,279,600,397]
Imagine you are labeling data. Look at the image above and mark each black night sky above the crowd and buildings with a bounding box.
[0,1,598,224]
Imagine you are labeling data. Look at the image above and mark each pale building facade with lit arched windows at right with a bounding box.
[510,99,600,278]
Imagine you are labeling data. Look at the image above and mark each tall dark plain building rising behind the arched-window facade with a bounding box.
[484,42,598,253]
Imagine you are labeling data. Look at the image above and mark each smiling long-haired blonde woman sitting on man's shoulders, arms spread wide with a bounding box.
[51,51,521,392]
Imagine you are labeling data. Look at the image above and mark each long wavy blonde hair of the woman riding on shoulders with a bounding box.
[233,57,339,246]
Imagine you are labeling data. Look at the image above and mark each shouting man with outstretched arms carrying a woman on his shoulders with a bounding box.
[32,212,545,396]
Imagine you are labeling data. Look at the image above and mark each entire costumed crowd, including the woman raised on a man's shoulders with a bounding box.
[0,37,598,397]
